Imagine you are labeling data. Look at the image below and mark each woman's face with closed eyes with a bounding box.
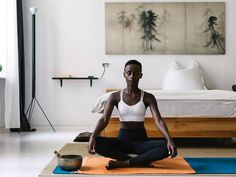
[124,64,142,86]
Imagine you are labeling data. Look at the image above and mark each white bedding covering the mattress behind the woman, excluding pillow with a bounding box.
[92,90,236,117]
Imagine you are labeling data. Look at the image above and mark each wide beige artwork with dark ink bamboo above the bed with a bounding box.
[105,2,225,55]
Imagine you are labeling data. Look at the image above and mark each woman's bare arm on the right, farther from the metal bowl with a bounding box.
[147,93,177,158]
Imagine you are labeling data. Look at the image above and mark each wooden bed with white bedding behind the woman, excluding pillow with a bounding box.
[92,89,236,138]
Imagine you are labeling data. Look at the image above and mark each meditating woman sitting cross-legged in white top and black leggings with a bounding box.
[88,60,177,169]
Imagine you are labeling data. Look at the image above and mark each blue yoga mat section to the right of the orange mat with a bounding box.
[184,157,236,174]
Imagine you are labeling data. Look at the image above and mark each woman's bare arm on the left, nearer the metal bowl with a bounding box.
[88,93,116,154]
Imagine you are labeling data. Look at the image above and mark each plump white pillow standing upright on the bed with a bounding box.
[162,61,206,90]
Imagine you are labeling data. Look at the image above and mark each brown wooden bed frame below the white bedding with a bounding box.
[101,89,236,138]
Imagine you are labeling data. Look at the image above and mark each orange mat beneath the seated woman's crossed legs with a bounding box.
[77,157,195,175]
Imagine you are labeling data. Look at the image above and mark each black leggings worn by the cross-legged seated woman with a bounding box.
[95,129,168,166]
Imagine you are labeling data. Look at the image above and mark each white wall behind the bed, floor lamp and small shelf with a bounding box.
[18,0,236,125]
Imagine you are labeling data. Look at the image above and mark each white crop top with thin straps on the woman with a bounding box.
[118,90,146,122]
